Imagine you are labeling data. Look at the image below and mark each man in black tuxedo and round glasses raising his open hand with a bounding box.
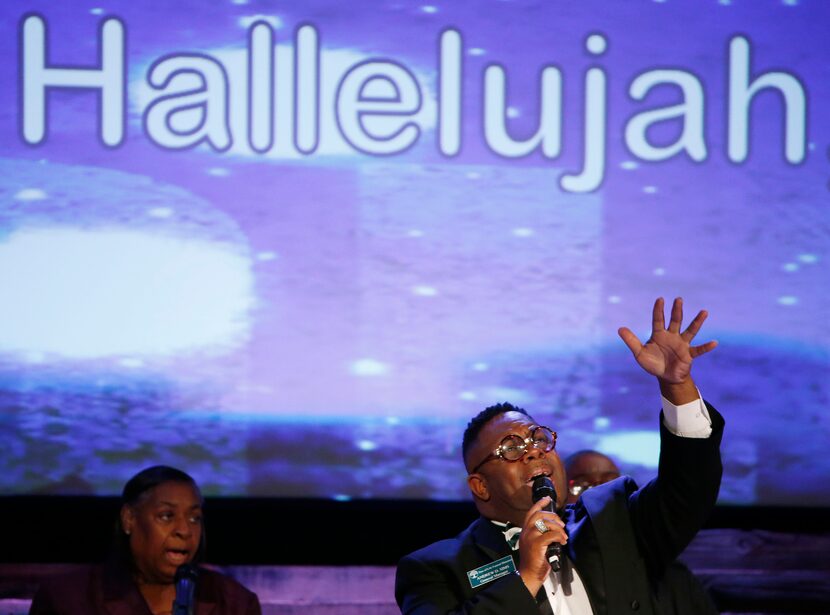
[395,299,723,615]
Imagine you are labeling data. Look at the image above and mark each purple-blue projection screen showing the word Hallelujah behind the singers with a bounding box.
[0,0,830,506]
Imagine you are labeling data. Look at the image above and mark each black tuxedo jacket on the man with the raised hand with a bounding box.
[395,404,723,615]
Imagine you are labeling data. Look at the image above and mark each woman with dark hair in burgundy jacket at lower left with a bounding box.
[29,466,261,615]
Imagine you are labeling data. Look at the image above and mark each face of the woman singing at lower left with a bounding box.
[121,482,202,583]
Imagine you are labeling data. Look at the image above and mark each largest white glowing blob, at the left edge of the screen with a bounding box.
[0,228,254,361]
